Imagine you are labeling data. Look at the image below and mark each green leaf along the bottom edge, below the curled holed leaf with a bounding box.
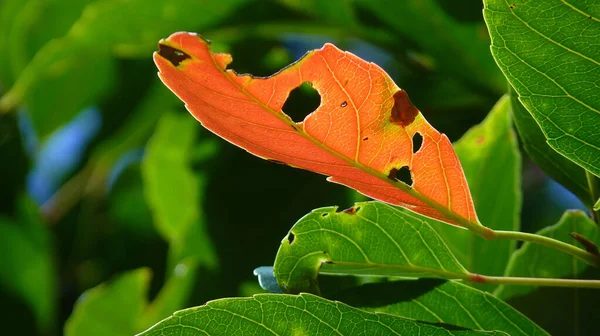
[140,294,506,336]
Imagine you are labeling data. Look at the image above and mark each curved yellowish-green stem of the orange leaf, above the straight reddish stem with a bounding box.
[492,231,600,267]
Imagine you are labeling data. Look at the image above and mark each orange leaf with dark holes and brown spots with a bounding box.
[154,33,481,228]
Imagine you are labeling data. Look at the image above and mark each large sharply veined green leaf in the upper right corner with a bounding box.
[483,0,600,176]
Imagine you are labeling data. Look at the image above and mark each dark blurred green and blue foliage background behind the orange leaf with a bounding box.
[0,0,582,335]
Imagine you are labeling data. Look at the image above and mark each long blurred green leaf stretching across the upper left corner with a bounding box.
[0,0,247,139]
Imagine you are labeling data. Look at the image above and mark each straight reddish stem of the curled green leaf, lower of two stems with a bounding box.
[469,274,600,288]
